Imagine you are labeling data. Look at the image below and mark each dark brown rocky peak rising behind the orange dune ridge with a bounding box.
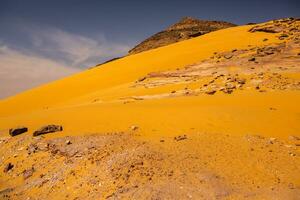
[129,17,236,55]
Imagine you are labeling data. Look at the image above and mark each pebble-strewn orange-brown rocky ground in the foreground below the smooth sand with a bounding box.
[0,130,300,199]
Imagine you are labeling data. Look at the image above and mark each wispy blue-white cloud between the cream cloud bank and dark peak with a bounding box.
[27,27,130,68]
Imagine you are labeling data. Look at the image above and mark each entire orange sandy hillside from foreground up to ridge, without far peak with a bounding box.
[0,18,300,199]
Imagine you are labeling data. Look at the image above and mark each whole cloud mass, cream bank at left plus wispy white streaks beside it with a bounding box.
[0,23,129,98]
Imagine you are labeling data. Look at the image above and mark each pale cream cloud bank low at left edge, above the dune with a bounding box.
[0,44,78,98]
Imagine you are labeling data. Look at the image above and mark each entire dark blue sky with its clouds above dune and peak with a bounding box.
[0,0,300,98]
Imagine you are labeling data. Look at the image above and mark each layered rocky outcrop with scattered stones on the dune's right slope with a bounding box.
[132,19,300,99]
